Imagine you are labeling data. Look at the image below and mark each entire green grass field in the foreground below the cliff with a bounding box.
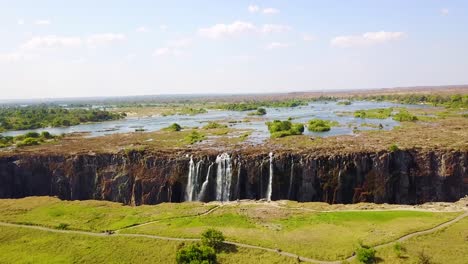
[0,197,462,263]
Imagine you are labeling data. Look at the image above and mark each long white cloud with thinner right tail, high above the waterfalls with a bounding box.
[198,21,291,39]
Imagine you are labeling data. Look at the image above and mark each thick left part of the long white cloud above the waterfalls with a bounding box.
[198,21,256,39]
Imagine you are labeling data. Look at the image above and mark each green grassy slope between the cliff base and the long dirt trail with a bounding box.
[0,197,458,262]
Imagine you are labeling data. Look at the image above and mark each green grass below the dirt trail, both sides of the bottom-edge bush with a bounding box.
[0,227,294,264]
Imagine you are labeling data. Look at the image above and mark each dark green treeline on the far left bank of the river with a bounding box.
[0,106,125,131]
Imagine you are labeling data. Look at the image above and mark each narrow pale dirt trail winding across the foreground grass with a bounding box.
[0,209,468,264]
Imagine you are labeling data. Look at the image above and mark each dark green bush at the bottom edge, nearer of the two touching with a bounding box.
[176,244,216,264]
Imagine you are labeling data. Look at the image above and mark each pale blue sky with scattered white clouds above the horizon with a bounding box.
[0,0,468,99]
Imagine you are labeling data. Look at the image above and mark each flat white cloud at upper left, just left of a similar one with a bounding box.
[20,35,82,50]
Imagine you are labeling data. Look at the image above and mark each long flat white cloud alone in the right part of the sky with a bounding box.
[330,31,405,48]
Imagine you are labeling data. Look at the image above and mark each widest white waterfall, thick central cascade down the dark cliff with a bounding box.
[216,153,232,202]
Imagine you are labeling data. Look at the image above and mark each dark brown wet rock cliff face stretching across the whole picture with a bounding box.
[0,151,468,205]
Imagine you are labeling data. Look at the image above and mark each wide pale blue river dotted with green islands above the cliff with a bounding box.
[2,101,429,142]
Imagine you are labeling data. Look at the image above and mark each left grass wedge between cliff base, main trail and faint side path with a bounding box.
[0,197,214,231]
